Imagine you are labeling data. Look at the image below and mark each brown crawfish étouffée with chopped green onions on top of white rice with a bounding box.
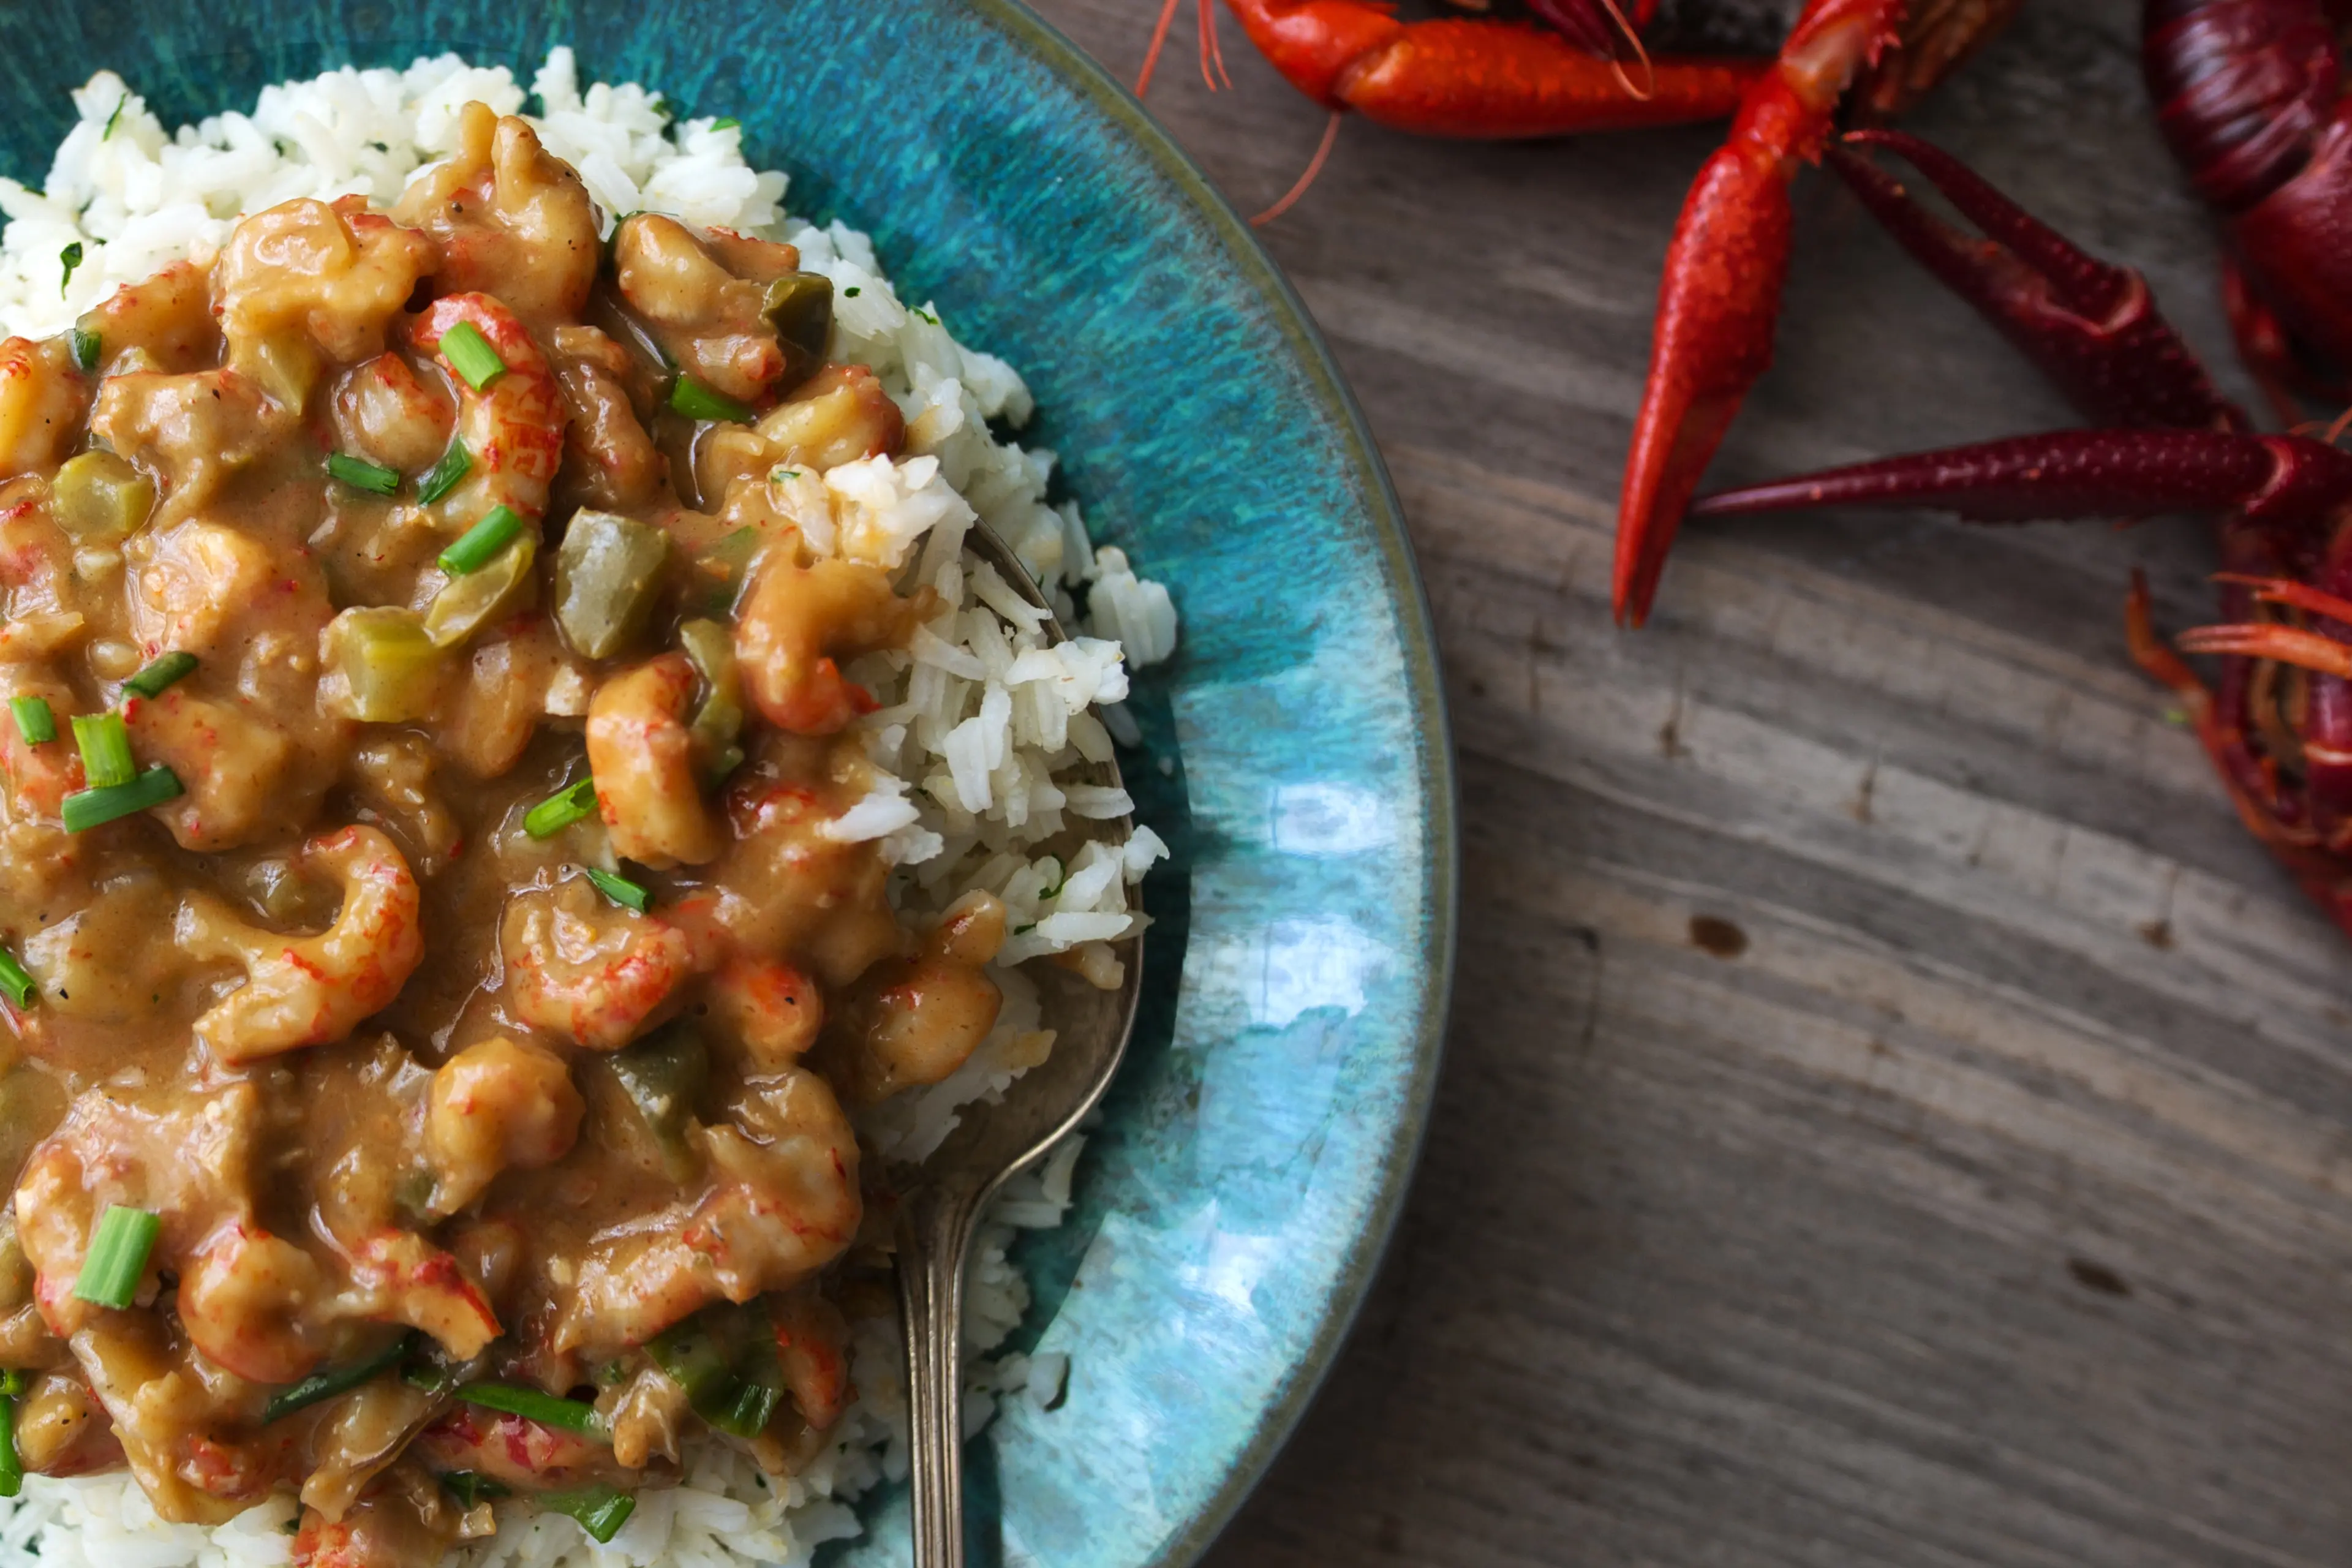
[0,104,1005,1568]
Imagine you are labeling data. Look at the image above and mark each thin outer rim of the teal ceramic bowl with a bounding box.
[964,0,1461,1568]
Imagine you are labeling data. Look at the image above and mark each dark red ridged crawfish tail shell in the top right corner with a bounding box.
[2140,0,2343,214]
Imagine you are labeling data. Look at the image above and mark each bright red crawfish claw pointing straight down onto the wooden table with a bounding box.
[1613,0,1903,625]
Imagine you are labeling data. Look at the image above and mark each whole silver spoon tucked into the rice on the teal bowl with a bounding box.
[896,522,1143,1568]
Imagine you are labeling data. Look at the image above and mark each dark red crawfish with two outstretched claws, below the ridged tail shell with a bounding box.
[1656,132,2352,931]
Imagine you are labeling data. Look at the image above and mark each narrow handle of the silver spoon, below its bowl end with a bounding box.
[899,1183,981,1568]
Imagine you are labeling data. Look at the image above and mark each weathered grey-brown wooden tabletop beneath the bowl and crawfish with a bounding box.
[1035,0,2352,1568]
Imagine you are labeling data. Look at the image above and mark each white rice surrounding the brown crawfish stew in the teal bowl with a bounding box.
[0,50,1176,1568]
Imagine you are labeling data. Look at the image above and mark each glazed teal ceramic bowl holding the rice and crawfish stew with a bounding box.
[0,0,1456,1568]
